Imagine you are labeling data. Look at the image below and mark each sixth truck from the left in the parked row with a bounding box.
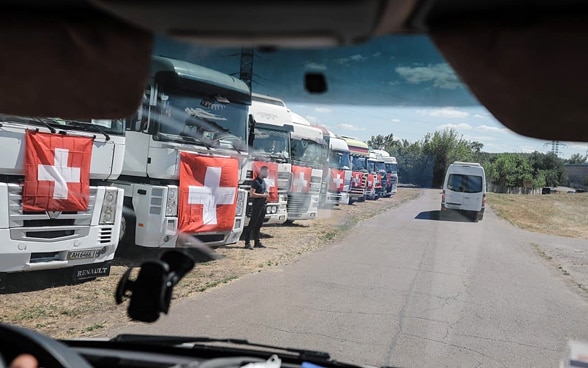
[342,136,369,203]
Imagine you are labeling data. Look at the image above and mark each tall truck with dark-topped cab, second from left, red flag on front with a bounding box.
[116,57,251,247]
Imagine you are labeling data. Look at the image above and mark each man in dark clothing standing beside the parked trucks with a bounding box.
[243,166,269,249]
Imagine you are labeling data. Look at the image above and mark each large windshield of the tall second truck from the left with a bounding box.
[157,93,247,148]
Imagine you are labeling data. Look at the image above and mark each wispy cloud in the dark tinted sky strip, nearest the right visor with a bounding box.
[395,63,462,89]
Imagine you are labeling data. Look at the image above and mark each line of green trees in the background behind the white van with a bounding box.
[367,129,586,188]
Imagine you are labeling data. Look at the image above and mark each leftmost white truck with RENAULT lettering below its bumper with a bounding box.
[0,115,125,281]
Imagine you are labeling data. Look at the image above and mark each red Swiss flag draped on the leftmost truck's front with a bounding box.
[22,130,94,212]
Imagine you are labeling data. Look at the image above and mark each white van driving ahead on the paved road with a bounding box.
[441,161,486,220]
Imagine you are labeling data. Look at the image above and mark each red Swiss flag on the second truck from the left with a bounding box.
[178,152,239,234]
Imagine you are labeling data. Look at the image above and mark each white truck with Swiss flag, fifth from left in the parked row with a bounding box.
[316,126,351,207]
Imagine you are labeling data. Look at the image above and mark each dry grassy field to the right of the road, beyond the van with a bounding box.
[488,193,588,239]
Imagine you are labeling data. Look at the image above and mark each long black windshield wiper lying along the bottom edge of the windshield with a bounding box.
[110,334,331,360]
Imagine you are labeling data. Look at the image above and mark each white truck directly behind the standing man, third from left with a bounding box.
[243,93,292,224]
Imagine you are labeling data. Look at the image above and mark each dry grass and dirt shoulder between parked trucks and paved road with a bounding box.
[0,188,422,338]
